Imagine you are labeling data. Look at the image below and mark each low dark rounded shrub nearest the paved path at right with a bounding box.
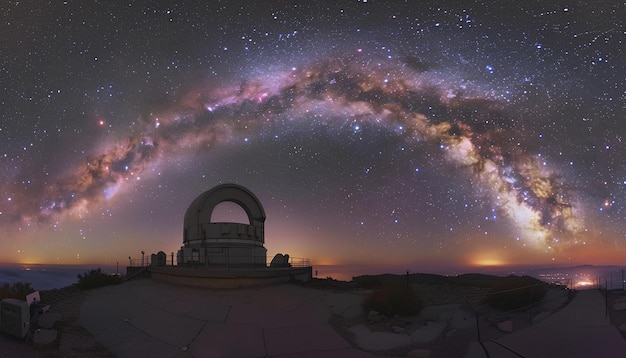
[485,276,548,310]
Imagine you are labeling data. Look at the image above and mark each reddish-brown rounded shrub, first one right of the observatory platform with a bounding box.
[362,279,423,316]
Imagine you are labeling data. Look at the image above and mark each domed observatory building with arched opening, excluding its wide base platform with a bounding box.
[177,184,267,268]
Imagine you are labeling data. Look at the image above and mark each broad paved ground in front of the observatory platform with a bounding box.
[80,279,380,358]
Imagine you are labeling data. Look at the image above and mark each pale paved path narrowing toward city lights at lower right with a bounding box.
[467,290,626,358]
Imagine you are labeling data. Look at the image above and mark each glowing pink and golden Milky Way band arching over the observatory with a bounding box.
[4,56,582,249]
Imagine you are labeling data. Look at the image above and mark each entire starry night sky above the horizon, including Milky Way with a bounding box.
[0,0,626,269]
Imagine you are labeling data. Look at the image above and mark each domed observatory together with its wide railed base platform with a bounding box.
[146,184,312,288]
